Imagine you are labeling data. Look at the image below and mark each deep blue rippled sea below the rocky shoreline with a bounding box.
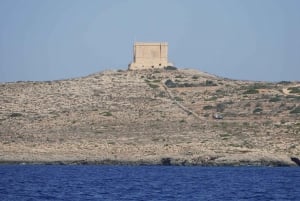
[0,165,300,201]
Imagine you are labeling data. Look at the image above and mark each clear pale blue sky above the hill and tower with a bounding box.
[0,0,300,82]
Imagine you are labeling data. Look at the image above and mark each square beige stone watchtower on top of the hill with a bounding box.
[128,42,172,70]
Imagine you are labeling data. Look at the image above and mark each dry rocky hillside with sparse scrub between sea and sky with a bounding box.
[0,70,300,165]
